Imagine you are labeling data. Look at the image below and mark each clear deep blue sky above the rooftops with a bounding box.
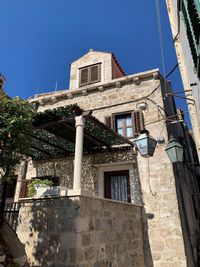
[0,0,186,123]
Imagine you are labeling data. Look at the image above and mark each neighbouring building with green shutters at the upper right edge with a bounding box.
[166,0,200,159]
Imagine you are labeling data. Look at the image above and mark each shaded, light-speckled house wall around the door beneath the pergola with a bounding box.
[33,151,142,204]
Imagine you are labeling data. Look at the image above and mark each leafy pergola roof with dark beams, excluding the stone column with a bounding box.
[32,104,129,160]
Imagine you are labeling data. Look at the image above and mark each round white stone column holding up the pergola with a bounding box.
[73,116,85,190]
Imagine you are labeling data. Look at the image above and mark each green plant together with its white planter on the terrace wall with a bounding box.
[28,179,59,197]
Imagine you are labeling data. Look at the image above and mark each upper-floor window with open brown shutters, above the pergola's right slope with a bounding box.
[105,110,144,138]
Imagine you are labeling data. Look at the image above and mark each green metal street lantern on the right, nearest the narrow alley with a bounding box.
[165,137,183,163]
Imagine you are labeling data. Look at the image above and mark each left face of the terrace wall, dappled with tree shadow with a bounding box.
[17,199,78,267]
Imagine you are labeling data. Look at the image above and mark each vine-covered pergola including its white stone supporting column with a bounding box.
[29,104,133,195]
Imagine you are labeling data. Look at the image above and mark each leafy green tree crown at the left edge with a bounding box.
[0,97,35,180]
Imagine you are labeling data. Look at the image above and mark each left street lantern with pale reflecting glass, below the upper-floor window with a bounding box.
[135,129,157,158]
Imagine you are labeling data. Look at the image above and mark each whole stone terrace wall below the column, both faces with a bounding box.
[17,196,144,267]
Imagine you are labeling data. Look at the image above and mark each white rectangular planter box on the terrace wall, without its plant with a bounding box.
[35,184,60,197]
